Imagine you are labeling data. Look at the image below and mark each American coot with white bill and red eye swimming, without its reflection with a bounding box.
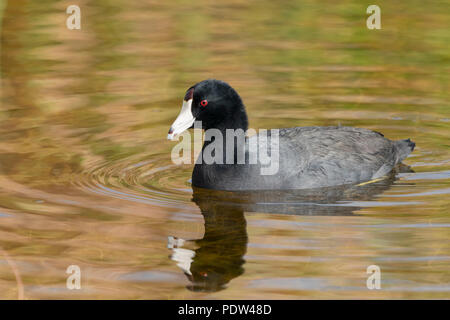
[168,79,415,190]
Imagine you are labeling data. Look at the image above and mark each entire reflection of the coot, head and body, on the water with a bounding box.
[169,168,407,292]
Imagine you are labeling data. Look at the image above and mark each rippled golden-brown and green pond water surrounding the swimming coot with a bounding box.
[0,0,450,299]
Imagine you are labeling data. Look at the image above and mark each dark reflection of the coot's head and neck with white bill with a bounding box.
[169,196,248,292]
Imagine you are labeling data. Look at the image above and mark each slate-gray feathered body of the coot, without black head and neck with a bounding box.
[192,127,415,190]
